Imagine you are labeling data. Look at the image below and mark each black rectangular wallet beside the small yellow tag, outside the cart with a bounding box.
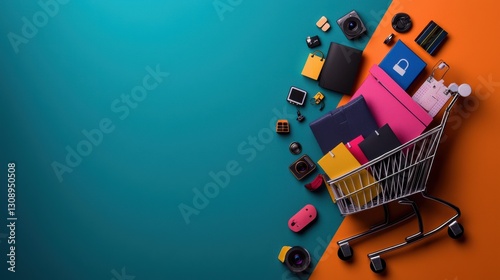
[318,42,363,95]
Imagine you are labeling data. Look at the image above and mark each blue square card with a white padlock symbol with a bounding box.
[379,40,427,90]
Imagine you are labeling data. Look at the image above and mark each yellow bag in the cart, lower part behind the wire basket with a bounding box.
[318,143,381,207]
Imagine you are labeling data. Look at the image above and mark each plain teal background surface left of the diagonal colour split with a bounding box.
[0,0,390,280]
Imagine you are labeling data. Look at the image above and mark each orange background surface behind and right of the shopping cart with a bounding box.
[310,0,500,280]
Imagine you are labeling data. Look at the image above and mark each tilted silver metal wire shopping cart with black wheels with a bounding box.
[327,77,471,273]
